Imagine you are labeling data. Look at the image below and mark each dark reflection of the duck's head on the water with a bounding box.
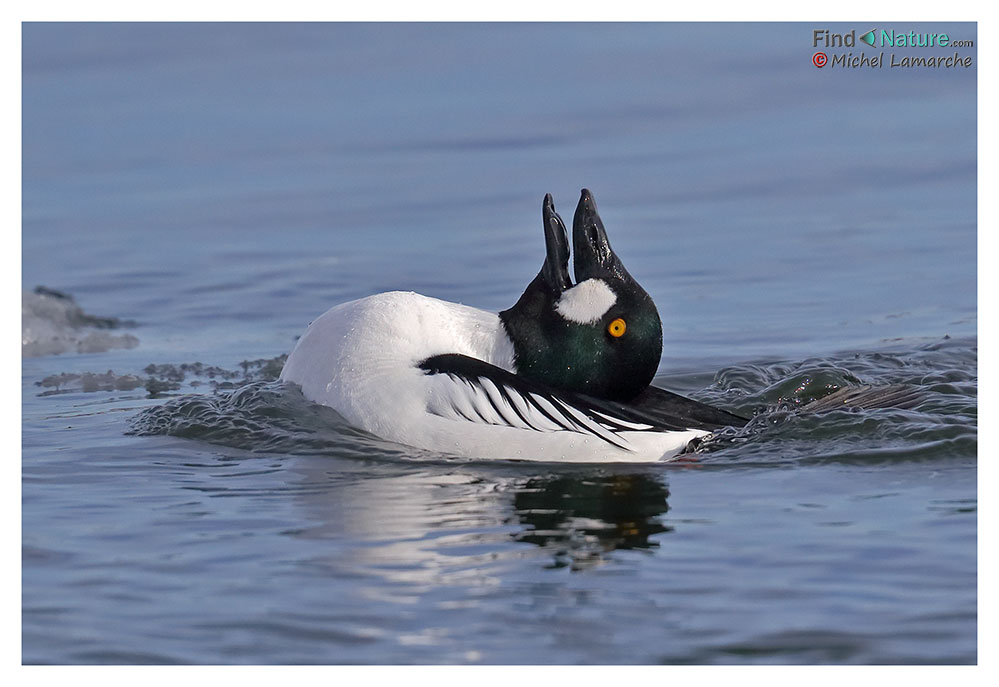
[513,474,673,569]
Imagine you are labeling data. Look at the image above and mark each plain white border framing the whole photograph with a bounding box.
[7,0,999,687]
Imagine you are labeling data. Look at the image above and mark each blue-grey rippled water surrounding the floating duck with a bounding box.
[22,24,977,663]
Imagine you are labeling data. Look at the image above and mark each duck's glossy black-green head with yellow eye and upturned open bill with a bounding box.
[500,188,663,400]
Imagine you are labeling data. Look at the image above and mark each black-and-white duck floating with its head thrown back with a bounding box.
[280,188,748,463]
